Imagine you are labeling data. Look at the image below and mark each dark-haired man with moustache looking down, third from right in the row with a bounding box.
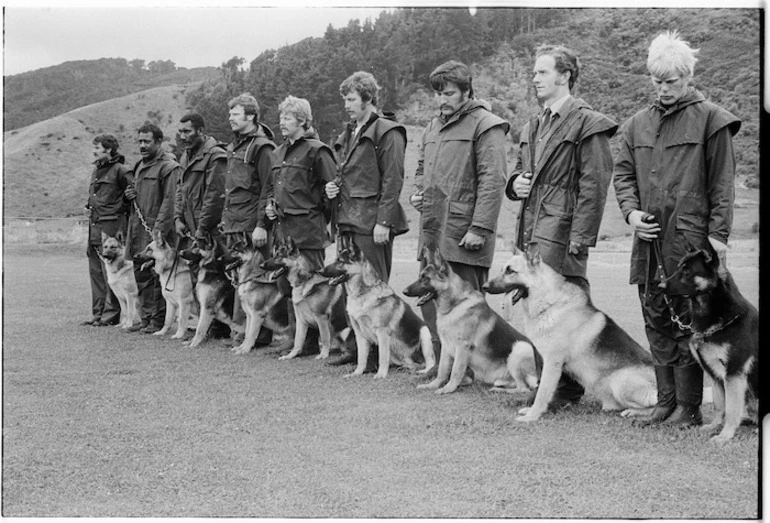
[409,60,510,366]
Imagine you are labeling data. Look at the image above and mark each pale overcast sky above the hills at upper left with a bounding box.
[4,5,390,75]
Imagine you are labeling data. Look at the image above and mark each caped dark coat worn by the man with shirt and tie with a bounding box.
[505,98,618,278]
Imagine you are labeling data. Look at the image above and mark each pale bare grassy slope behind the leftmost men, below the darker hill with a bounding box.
[3,86,195,217]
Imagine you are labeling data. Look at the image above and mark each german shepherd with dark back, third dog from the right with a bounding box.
[404,248,537,394]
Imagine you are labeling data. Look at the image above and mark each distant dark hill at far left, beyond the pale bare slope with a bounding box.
[4,58,219,131]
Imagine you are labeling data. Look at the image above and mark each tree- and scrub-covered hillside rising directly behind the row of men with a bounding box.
[187,8,760,181]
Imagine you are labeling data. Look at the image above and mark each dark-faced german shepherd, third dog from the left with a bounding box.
[186,233,244,347]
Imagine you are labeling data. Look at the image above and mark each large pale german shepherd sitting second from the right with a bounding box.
[484,247,657,421]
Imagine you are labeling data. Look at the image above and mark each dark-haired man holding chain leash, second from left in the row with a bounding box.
[126,123,181,334]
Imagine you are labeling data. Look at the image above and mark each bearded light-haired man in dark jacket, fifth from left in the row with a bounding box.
[266,96,337,270]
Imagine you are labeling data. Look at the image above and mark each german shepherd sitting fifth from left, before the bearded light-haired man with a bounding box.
[262,237,350,360]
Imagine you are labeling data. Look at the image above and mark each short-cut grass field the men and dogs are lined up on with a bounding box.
[2,244,759,519]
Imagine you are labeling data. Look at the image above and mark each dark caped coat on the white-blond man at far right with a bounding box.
[614,88,741,284]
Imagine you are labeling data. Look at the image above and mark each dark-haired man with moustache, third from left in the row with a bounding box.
[174,113,227,248]
